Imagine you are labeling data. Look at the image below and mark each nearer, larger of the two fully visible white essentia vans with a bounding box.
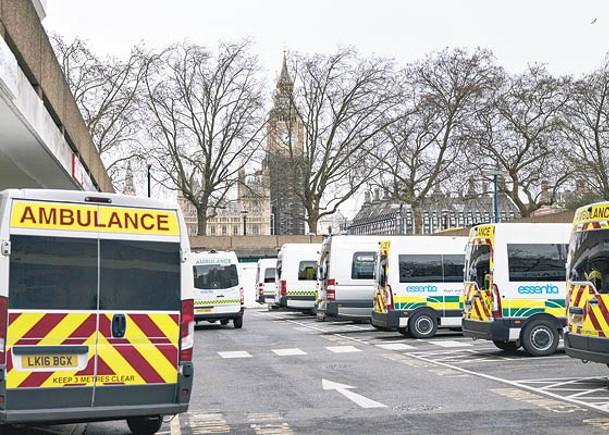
[463,223,571,356]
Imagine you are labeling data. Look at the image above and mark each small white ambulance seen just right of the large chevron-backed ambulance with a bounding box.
[193,250,244,329]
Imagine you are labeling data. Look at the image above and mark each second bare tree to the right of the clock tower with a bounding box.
[376,49,501,234]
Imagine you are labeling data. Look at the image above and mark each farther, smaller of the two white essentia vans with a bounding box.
[372,236,467,338]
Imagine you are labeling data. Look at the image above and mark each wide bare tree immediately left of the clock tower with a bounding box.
[145,41,265,235]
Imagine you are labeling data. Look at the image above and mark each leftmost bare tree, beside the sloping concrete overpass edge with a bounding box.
[51,34,146,187]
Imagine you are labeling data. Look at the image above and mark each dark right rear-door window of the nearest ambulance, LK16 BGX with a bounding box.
[99,239,181,311]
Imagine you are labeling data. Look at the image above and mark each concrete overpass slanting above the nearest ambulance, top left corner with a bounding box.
[0,0,114,192]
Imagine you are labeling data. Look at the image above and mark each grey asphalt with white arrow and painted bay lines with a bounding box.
[3,309,609,435]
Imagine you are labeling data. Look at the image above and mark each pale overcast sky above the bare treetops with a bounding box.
[43,0,609,77]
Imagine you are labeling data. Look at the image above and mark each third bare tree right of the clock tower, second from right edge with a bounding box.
[470,65,572,217]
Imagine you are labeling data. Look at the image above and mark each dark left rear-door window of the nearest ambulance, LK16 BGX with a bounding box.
[8,235,98,310]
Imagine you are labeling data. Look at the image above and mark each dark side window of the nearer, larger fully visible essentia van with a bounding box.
[507,243,568,282]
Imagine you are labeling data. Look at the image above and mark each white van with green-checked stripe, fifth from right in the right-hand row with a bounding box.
[274,243,321,312]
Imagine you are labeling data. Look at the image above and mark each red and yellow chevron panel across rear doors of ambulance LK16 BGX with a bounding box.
[6,312,179,388]
